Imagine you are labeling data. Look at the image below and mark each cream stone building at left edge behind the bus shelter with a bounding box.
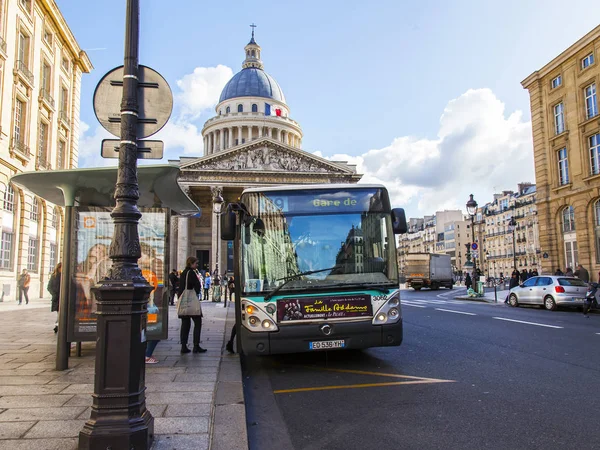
[0,0,92,301]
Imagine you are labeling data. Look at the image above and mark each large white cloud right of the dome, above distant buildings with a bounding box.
[316,89,535,217]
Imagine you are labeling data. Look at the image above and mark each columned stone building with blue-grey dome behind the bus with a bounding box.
[170,31,362,273]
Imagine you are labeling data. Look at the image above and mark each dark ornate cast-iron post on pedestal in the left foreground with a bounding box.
[79,0,154,450]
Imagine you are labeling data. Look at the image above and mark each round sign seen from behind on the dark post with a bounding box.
[94,66,173,139]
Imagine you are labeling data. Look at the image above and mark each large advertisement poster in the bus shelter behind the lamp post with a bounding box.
[69,207,168,341]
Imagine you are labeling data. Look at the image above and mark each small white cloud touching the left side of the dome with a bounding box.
[176,64,233,118]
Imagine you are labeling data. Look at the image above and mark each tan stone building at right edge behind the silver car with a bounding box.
[521,26,600,281]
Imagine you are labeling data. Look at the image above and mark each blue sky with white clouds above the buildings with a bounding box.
[56,0,600,216]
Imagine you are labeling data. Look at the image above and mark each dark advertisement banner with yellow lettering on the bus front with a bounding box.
[277,295,373,322]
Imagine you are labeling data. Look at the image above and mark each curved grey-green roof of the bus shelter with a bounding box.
[11,165,200,216]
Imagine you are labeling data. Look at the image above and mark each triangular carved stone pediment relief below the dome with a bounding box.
[183,146,351,173]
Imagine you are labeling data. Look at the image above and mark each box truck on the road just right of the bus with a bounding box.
[404,253,454,291]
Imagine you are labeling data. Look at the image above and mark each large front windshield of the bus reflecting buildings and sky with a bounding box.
[241,188,398,294]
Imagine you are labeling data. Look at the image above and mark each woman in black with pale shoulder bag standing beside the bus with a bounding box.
[177,256,206,353]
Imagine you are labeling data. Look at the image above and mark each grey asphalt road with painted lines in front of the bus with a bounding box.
[243,290,600,450]
